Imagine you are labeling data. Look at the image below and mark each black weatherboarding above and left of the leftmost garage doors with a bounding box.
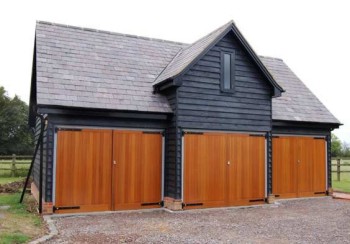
[35,109,168,202]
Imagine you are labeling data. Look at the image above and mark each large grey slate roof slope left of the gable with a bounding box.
[36,22,186,112]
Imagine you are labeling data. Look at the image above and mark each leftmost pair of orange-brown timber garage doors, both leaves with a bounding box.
[54,129,162,213]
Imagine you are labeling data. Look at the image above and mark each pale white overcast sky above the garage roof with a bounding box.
[0,0,350,142]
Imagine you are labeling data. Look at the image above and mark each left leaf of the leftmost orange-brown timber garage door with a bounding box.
[55,130,112,213]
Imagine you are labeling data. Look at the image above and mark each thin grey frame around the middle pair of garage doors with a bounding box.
[181,129,268,202]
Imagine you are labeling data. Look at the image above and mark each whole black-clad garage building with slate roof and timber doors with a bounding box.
[29,21,341,213]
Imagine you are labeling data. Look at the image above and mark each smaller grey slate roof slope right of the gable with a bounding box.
[260,57,340,124]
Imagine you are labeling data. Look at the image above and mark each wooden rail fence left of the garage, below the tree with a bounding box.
[0,154,33,177]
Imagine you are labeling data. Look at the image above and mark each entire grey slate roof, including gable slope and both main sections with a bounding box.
[36,22,339,124]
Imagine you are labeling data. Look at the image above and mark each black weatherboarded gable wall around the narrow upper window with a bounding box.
[178,33,272,132]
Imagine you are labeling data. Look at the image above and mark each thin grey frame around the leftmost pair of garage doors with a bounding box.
[53,125,165,206]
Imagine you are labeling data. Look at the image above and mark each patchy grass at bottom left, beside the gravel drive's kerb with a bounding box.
[0,193,46,244]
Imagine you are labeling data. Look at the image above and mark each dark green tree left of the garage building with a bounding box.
[0,87,34,155]
